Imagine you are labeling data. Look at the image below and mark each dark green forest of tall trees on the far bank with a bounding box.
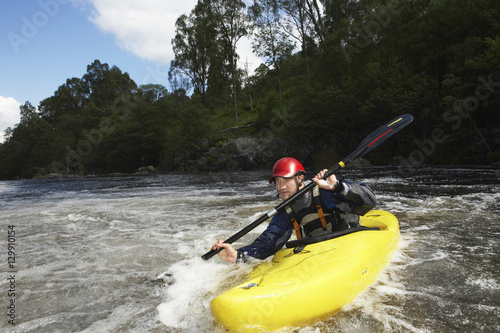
[0,0,500,179]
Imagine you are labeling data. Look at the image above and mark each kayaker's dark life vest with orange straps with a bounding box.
[285,186,350,239]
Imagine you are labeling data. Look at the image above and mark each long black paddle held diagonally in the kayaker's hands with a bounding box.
[201,114,413,260]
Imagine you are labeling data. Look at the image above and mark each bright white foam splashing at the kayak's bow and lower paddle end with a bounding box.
[157,205,267,332]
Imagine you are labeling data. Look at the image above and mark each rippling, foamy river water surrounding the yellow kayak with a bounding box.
[0,168,500,333]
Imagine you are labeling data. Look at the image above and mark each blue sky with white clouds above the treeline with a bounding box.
[0,0,260,142]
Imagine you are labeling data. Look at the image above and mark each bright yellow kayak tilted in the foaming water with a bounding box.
[210,210,399,332]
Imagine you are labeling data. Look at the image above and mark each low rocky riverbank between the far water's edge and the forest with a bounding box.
[28,134,500,179]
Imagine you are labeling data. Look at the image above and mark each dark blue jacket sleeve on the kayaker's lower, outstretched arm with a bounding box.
[237,211,293,259]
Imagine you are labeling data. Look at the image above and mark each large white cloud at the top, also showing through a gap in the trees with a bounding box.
[76,0,262,72]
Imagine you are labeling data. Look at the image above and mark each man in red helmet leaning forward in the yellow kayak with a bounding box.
[212,157,376,262]
